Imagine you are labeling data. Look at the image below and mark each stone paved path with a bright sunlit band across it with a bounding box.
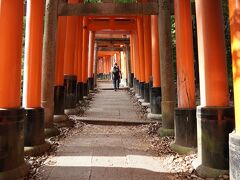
[41,82,174,180]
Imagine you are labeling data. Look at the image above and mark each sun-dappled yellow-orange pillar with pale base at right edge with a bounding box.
[229,0,240,179]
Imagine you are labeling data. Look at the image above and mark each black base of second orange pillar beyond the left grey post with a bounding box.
[64,75,77,109]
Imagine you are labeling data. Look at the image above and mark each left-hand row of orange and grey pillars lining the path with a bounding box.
[0,0,97,179]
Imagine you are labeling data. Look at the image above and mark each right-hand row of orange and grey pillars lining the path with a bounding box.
[130,0,240,179]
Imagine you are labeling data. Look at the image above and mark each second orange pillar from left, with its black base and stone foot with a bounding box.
[23,0,49,155]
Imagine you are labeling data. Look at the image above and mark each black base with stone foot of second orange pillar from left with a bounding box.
[24,107,49,155]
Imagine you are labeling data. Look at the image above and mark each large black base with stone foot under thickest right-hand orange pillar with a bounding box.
[194,106,234,178]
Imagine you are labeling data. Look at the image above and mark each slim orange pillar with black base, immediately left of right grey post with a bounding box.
[148,15,161,120]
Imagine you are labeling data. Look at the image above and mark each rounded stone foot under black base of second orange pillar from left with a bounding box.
[24,141,50,156]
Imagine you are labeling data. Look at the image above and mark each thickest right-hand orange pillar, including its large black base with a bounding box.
[193,0,234,176]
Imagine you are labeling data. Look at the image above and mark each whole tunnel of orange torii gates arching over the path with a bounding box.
[0,0,240,179]
